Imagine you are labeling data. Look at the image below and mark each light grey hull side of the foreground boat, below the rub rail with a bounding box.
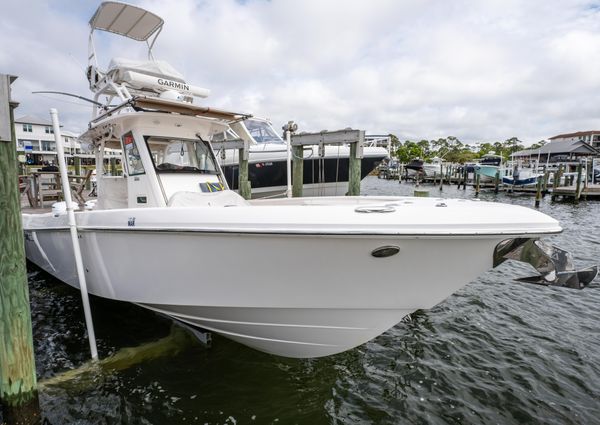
[26,224,502,357]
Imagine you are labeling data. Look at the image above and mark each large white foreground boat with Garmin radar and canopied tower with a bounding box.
[23,2,595,357]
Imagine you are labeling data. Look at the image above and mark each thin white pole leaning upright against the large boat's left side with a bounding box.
[50,108,98,359]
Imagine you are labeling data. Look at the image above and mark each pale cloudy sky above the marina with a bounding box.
[0,0,600,145]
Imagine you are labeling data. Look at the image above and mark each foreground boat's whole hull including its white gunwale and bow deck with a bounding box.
[23,197,560,358]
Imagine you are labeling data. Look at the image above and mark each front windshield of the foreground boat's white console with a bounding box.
[145,136,217,174]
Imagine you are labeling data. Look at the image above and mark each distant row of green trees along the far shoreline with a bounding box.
[390,134,546,164]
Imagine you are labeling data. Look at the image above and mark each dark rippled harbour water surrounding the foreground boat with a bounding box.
[7,177,600,424]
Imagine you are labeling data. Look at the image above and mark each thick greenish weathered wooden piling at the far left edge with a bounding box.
[0,74,40,424]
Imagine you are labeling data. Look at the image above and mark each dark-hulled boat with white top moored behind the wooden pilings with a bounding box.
[217,117,389,198]
